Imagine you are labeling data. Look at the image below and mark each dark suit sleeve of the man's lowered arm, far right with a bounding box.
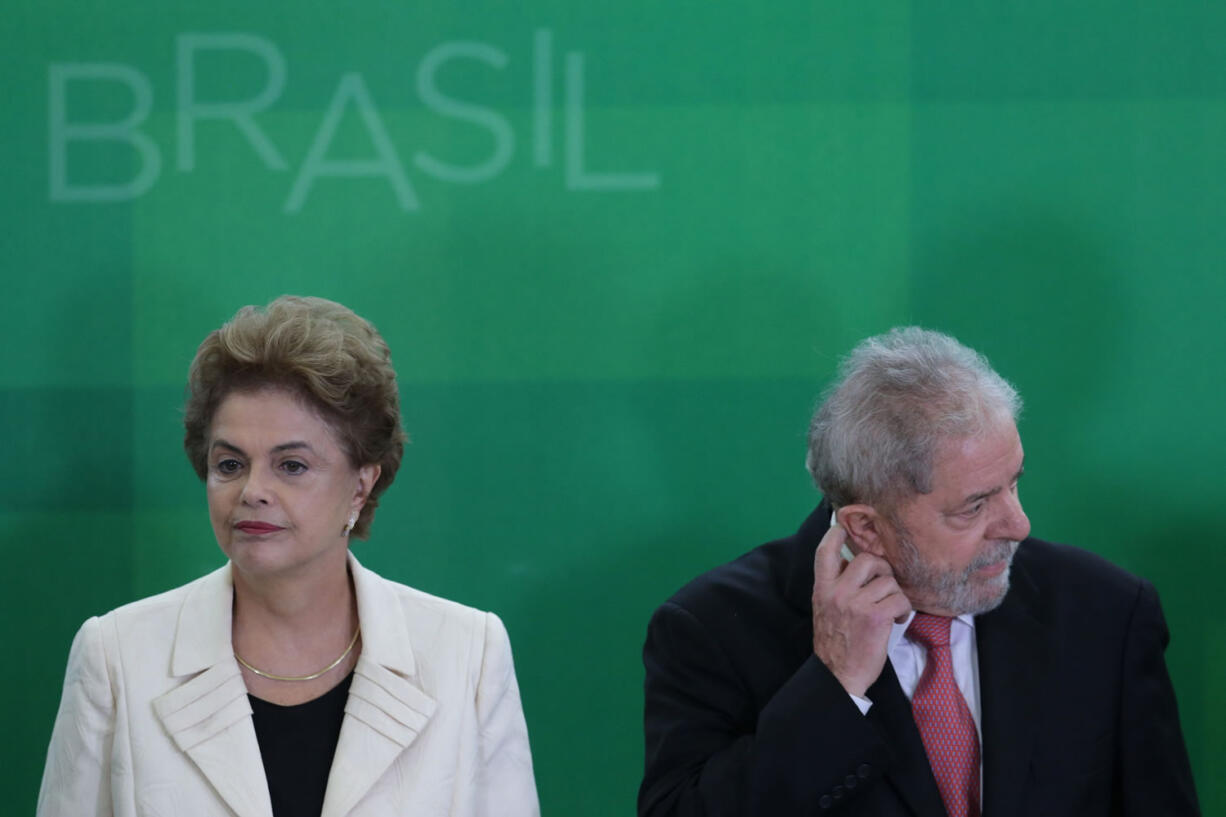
[1117,581,1200,817]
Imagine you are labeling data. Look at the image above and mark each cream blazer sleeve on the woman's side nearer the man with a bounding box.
[477,613,541,817]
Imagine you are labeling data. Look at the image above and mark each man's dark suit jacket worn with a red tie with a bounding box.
[639,503,1199,817]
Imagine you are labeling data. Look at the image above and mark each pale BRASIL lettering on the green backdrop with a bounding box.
[48,29,660,213]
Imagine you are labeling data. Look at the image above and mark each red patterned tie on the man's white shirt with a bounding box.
[907,613,980,817]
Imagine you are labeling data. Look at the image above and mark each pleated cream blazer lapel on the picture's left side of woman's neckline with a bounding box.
[153,564,272,817]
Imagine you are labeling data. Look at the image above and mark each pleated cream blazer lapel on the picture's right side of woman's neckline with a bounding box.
[321,553,438,817]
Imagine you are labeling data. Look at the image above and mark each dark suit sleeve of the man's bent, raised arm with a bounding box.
[639,604,888,817]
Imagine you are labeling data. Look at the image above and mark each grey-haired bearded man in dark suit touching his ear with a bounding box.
[639,328,1199,817]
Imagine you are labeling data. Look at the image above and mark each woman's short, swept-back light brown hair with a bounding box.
[183,296,408,539]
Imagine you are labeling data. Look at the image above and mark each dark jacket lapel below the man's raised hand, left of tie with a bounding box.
[866,660,945,817]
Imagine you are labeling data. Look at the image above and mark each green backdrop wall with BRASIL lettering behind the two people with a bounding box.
[0,0,1226,817]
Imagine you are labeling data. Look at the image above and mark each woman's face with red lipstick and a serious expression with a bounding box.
[206,389,379,578]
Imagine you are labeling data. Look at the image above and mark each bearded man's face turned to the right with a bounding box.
[883,420,1030,616]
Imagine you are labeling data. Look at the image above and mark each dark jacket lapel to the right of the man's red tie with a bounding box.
[975,543,1048,817]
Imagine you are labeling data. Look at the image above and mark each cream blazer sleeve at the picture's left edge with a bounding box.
[36,618,115,817]
